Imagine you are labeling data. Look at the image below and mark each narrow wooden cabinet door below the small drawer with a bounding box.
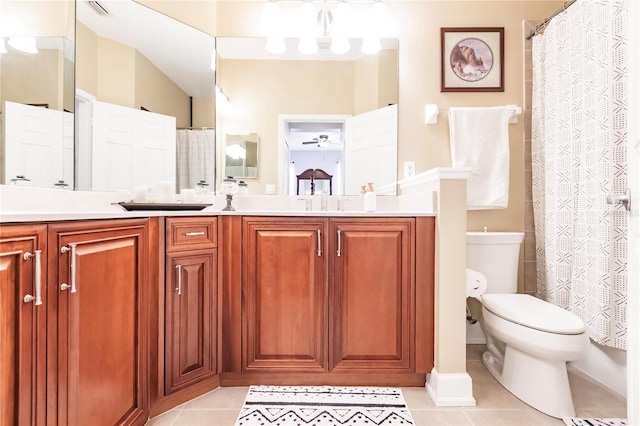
[165,250,217,395]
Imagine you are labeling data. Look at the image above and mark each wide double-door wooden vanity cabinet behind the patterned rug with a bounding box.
[236,217,434,386]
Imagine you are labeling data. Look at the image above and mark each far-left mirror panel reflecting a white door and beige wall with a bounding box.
[0,0,75,188]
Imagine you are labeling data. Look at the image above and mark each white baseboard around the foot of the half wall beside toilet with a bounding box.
[426,367,476,407]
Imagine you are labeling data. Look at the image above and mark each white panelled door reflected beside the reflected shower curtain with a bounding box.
[91,101,176,191]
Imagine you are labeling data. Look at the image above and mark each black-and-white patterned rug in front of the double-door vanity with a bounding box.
[236,386,414,426]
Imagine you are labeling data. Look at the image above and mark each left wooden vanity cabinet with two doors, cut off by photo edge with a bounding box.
[0,219,150,425]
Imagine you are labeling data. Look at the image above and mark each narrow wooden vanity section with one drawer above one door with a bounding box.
[164,217,218,395]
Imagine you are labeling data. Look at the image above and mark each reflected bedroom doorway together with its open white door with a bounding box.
[278,105,398,195]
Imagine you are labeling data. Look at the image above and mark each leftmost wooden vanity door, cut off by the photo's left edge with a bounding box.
[0,225,47,426]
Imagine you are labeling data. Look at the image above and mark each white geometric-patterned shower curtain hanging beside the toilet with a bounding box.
[531,0,628,349]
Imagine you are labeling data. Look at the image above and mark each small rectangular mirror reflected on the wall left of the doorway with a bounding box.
[224,133,258,179]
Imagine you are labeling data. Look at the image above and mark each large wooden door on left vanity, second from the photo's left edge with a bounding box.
[47,219,151,425]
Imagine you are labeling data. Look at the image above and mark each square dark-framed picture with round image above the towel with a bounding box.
[440,27,504,92]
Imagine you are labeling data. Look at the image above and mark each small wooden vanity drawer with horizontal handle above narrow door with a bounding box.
[166,217,218,252]
